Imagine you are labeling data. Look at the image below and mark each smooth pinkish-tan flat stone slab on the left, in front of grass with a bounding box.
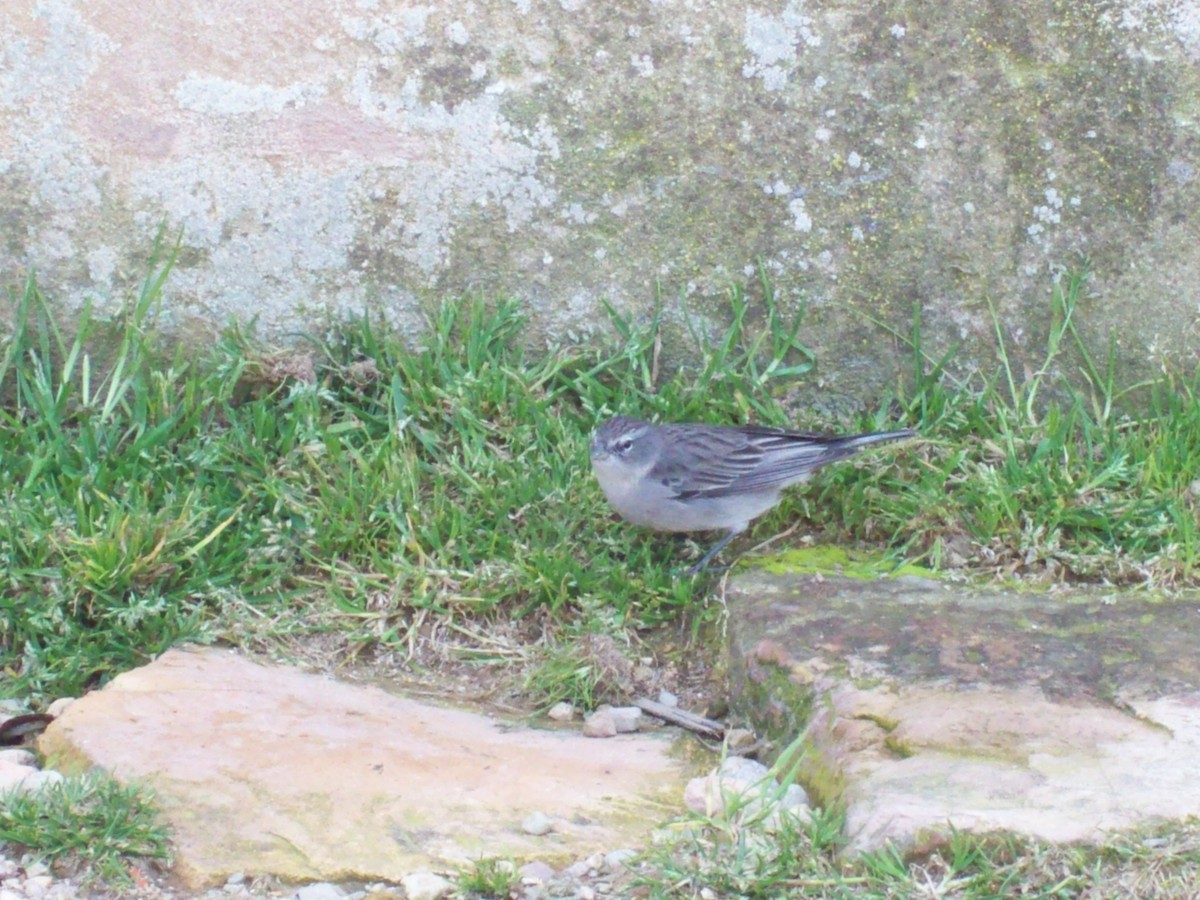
[40,649,691,887]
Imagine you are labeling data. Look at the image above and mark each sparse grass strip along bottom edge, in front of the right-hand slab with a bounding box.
[637,811,1200,900]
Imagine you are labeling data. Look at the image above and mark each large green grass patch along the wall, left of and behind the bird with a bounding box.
[0,252,835,702]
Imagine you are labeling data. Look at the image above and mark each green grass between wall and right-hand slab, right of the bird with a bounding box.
[820,268,1200,588]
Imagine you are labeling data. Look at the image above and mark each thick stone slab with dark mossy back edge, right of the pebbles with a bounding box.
[727,571,1200,850]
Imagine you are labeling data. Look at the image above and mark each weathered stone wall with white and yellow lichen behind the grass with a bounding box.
[0,0,1200,396]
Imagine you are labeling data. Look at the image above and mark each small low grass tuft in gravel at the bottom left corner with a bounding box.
[0,774,169,889]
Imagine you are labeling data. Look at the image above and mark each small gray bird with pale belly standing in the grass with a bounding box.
[592,415,913,575]
